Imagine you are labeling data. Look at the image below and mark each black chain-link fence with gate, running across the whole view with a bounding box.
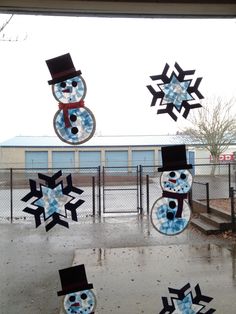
[0,163,236,221]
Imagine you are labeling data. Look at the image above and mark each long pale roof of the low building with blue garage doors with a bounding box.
[0,135,199,148]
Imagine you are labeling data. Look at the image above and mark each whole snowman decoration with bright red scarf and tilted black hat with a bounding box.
[46,53,96,145]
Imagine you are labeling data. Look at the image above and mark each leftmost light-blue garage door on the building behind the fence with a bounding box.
[25,151,48,169]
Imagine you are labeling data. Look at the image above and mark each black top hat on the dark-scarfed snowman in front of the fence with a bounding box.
[158,145,193,172]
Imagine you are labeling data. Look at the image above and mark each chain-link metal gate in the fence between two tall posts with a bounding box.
[102,166,142,213]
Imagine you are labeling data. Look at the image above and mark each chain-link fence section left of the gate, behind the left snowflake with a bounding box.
[0,167,100,222]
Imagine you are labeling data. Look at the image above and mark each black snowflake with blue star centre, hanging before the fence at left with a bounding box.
[21,170,84,231]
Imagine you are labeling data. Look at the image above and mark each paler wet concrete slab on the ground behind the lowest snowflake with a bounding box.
[74,244,236,314]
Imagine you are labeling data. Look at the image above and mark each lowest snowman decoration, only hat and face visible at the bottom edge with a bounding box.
[57,264,96,314]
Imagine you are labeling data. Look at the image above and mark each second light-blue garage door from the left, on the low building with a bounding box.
[52,152,75,171]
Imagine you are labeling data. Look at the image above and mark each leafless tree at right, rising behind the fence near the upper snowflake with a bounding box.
[183,98,236,175]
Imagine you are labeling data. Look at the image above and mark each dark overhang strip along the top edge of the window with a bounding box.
[0,0,236,18]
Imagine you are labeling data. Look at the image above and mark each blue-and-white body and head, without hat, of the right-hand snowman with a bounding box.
[151,169,193,235]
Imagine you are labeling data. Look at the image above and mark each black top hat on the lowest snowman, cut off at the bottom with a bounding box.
[57,264,93,296]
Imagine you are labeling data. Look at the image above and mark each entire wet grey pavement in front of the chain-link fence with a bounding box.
[0,216,236,314]
